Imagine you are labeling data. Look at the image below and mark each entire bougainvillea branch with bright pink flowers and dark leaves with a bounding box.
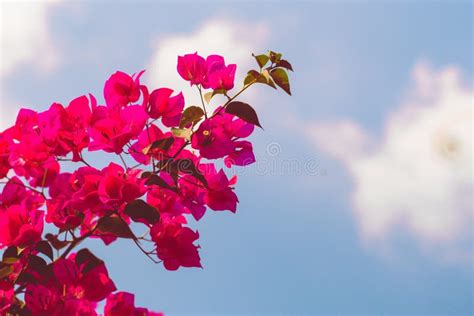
[0,52,292,316]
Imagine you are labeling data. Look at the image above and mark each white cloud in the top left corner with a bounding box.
[0,1,59,130]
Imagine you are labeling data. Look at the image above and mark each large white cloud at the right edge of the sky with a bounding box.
[308,62,474,260]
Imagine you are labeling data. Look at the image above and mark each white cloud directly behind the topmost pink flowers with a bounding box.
[145,18,269,109]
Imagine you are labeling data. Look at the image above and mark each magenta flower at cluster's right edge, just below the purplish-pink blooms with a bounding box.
[200,164,239,212]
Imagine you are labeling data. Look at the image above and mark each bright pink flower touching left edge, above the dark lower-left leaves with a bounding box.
[0,205,44,248]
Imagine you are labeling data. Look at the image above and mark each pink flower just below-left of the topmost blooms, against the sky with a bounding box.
[147,88,184,127]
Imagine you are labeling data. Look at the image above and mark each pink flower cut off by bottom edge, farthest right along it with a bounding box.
[104,292,164,316]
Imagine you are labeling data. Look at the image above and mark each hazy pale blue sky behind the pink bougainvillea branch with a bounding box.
[0,1,474,316]
